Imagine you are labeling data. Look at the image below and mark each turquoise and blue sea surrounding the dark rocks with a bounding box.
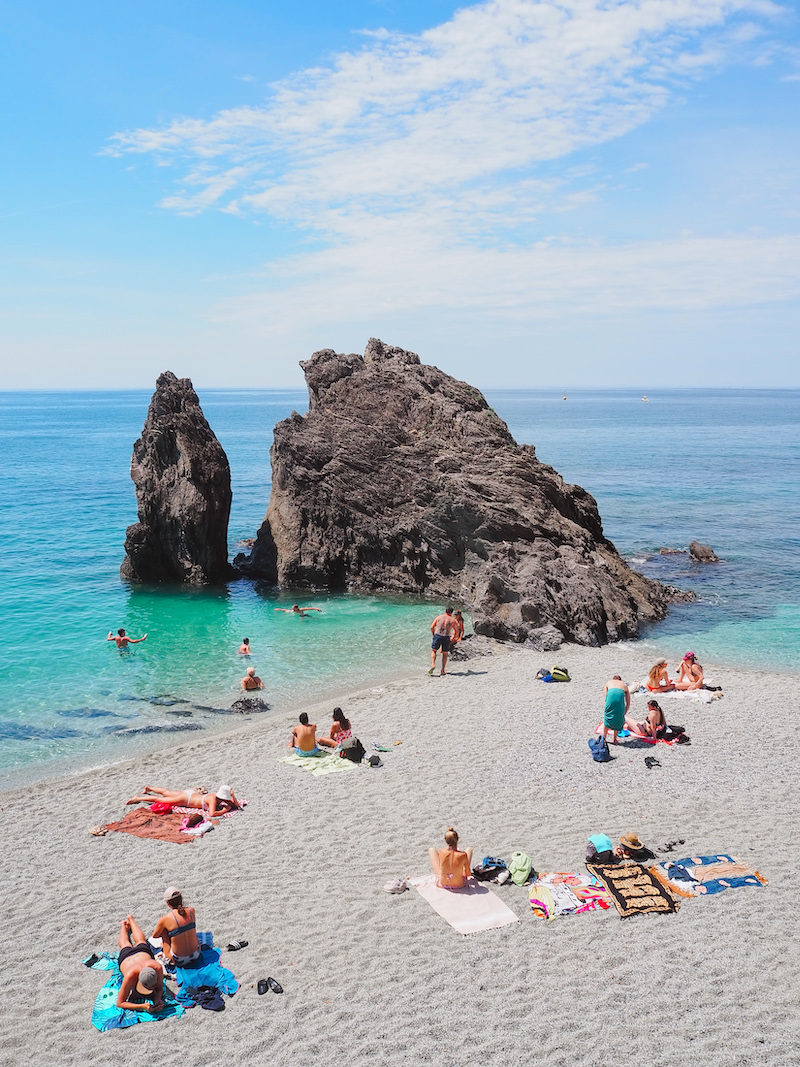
[0,389,800,786]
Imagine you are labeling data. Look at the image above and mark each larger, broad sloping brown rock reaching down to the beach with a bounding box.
[243,338,669,648]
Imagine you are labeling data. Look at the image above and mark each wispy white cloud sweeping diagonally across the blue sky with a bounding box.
[108,0,798,322]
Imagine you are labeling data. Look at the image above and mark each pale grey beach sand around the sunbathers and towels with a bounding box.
[0,648,800,1067]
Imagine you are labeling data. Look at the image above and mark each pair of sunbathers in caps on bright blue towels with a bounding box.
[116,886,201,1015]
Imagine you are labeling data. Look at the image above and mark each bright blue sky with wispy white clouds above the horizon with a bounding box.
[0,0,800,389]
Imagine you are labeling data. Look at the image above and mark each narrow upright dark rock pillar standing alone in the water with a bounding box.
[121,370,235,585]
